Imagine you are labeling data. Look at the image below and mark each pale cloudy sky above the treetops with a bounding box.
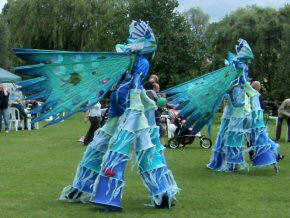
[0,0,290,21]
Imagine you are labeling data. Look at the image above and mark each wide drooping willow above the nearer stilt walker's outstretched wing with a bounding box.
[8,0,127,51]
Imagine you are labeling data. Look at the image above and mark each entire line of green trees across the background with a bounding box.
[0,0,290,100]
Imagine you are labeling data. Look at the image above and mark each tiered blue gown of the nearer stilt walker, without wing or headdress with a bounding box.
[56,21,178,208]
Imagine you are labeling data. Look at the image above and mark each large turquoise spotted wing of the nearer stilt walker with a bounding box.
[14,49,133,125]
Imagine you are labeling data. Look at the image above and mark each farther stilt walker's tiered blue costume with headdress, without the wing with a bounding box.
[207,40,279,172]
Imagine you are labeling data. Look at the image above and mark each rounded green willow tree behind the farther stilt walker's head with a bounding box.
[207,6,283,100]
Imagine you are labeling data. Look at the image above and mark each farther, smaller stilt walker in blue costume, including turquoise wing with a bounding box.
[164,39,279,172]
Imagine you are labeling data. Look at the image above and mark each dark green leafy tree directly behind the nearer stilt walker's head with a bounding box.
[129,0,205,89]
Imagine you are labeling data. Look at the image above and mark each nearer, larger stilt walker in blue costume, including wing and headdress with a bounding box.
[14,20,179,209]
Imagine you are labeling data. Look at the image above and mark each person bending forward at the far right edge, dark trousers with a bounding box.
[276,98,290,142]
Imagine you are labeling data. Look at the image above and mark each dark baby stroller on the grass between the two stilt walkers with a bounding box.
[168,112,212,149]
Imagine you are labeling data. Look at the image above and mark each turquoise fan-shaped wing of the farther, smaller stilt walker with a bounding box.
[163,65,238,134]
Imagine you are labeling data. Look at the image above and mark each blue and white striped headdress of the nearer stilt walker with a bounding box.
[116,19,157,54]
